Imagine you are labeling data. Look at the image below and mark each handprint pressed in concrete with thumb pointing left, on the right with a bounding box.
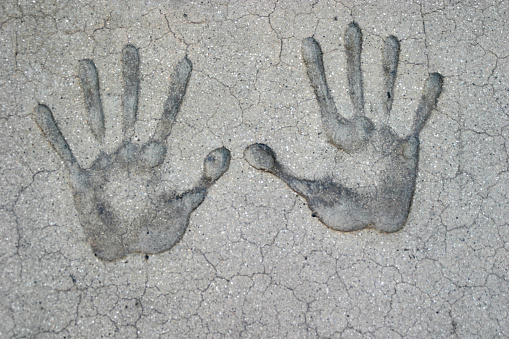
[244,22,443,232]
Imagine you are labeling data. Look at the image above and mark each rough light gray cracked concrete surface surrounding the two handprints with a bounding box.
[0,0,509,338]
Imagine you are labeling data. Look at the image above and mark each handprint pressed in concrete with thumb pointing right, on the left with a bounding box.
[34,45,230,261]
